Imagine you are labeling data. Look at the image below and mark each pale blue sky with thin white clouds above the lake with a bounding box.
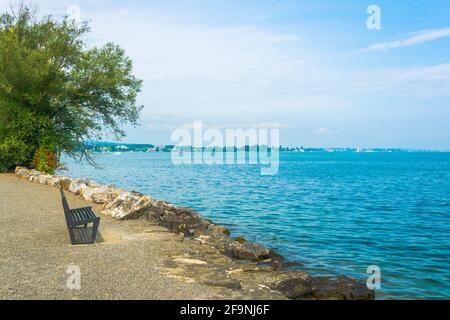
[0,0,450,149]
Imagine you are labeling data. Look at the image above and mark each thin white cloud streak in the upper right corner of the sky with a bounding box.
[358,27,450,52]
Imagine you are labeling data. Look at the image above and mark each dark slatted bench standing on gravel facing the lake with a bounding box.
[60,189,100,245]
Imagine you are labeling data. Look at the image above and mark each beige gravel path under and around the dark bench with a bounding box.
[0,174,228,299]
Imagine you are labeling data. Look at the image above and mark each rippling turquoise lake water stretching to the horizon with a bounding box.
[63,152,450,299]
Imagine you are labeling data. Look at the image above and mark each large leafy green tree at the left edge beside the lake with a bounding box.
[0,6,142,172]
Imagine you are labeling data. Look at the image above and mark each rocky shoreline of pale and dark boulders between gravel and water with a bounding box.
[15,167,375,300]
